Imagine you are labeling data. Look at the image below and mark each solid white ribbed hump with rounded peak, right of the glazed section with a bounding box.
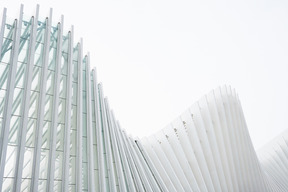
[141,86,269,192]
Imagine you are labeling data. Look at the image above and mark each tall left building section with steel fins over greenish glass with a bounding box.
[0,6,165,191]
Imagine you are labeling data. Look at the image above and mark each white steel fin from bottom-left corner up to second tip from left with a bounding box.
[0,4,23,190]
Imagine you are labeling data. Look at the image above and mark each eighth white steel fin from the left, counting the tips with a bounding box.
[86,53,95,191]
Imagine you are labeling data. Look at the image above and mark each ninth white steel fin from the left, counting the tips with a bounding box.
[92,68,107,191]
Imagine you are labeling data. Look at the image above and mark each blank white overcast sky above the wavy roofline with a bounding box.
[0,0,288,148]
